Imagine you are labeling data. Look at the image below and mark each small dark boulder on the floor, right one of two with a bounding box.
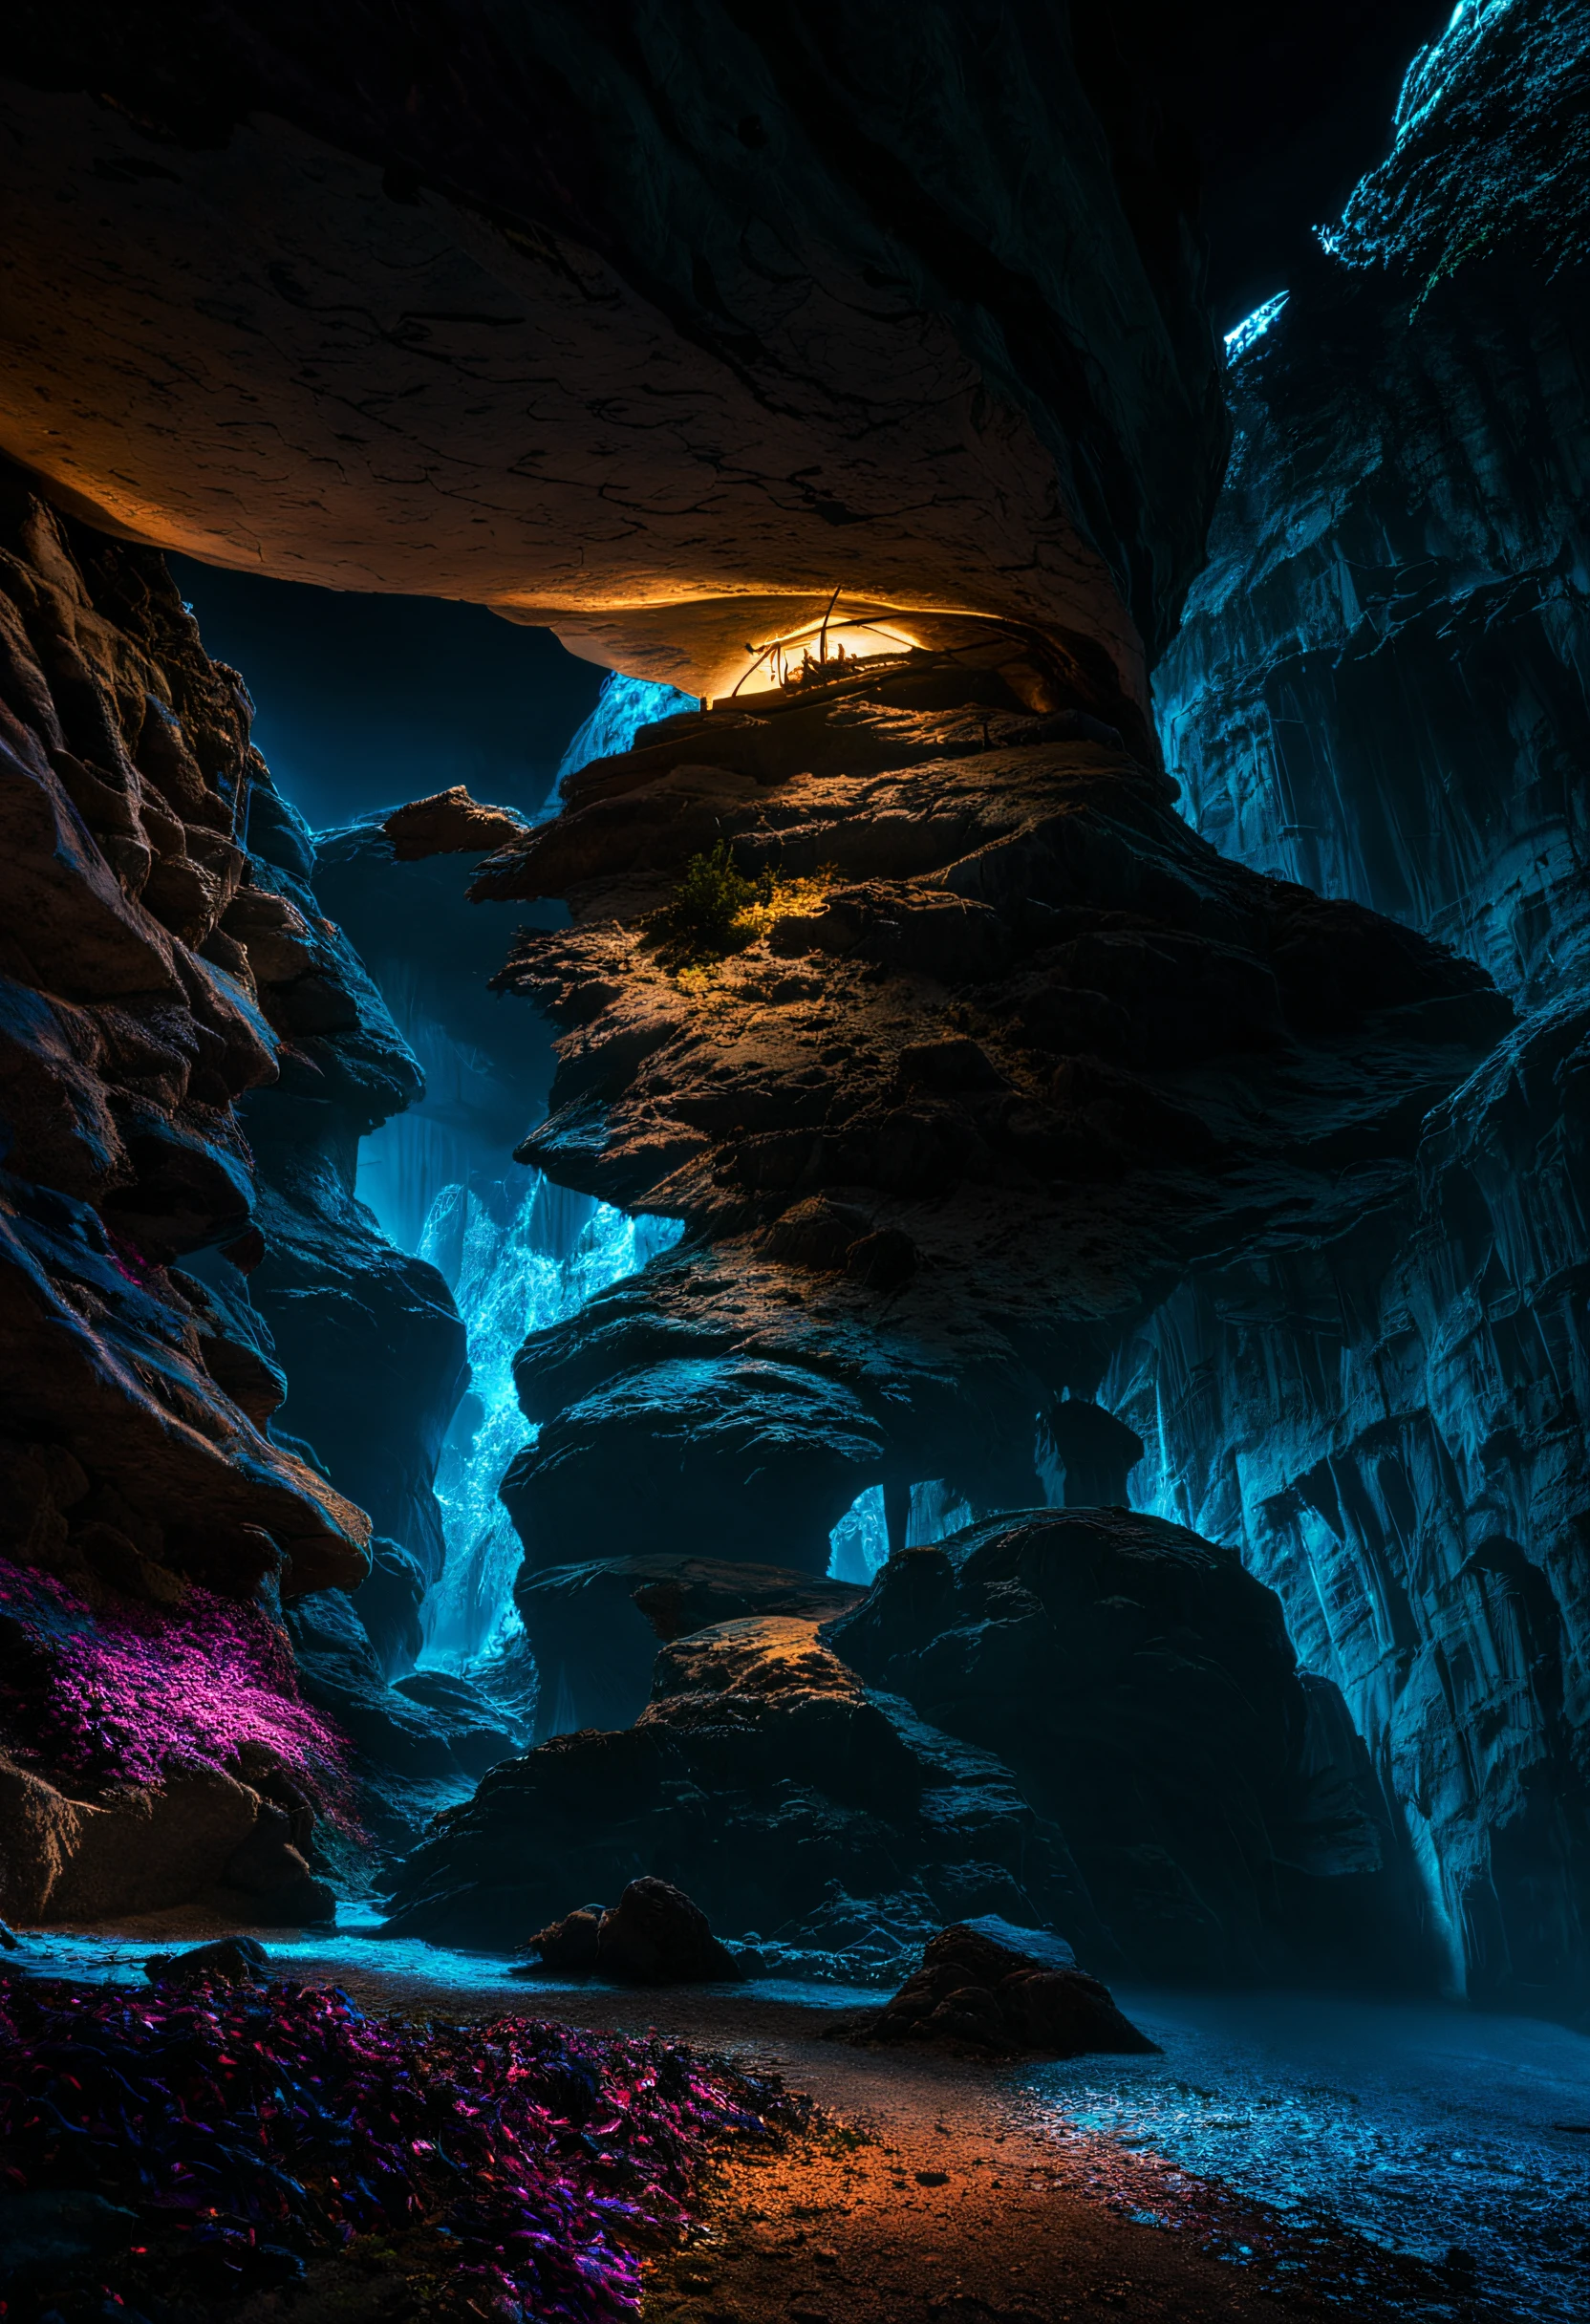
[850,1922,1160,2056]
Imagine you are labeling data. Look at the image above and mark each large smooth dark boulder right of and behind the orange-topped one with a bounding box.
[823,1515,1423,1980]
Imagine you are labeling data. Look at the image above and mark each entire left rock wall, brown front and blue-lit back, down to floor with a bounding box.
[0,477,483,1920]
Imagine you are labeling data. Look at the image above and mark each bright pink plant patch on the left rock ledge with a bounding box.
[0,1560,349,1808]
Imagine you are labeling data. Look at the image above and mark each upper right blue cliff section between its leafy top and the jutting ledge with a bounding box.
[1155,256,1590,1000]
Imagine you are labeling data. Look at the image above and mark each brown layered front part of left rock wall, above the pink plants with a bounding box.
[0,481,370,1597]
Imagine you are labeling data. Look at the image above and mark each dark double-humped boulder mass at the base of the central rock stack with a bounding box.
[391,1511,1418,1978]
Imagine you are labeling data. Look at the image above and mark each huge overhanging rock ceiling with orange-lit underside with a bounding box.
[0,0,1225,709]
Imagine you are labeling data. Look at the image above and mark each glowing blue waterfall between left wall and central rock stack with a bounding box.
[420,1172,683,1668]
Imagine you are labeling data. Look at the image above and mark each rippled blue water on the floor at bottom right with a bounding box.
[1027,1987,1590,2324]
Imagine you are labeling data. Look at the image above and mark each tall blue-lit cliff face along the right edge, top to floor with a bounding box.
[1129,5,1590,2008]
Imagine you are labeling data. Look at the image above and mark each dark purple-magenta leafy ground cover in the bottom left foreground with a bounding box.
[0,1978,797,2324]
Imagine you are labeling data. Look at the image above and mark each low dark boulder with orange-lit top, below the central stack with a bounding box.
[386,1615,1095,1957]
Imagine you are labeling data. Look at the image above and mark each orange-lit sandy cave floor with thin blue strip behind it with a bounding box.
[12,1917,1541,2324]
